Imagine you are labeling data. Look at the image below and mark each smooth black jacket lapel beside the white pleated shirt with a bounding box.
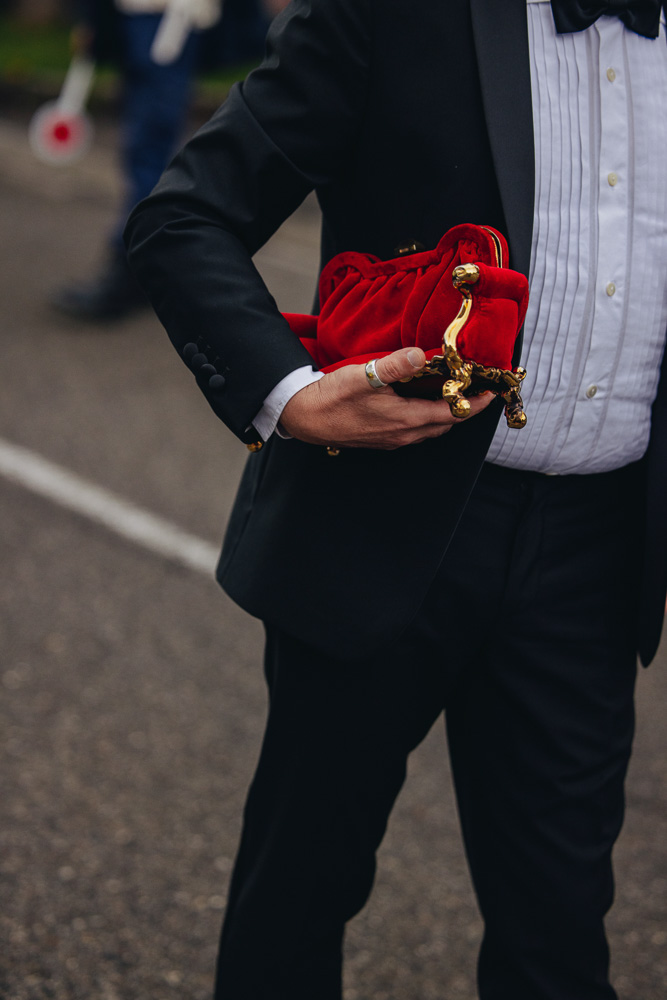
[470,0,535,274]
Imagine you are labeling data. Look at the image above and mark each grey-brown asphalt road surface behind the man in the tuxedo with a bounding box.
[0,109,667,1000]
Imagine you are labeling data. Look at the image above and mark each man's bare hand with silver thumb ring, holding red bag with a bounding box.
[280,347,493,450]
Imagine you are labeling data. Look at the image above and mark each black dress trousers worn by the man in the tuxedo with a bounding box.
[216,466,642,1000]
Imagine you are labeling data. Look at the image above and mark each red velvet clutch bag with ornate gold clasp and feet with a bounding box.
[285,224,528,427]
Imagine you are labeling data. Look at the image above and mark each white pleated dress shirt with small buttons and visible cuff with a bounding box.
[254,0,667,474]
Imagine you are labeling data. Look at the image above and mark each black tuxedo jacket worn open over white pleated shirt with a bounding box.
[128,0,667,662]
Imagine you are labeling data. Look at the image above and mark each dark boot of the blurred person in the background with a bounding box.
[51,249,148,320]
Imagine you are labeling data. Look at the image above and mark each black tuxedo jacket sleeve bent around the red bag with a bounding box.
[125,0,371,443]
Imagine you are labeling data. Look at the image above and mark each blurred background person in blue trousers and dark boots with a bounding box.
[52,0,272,320]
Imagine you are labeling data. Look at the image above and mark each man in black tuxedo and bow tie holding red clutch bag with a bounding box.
[128,0,667,1000]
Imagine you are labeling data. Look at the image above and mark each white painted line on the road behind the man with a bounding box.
[0,438,219,576]
